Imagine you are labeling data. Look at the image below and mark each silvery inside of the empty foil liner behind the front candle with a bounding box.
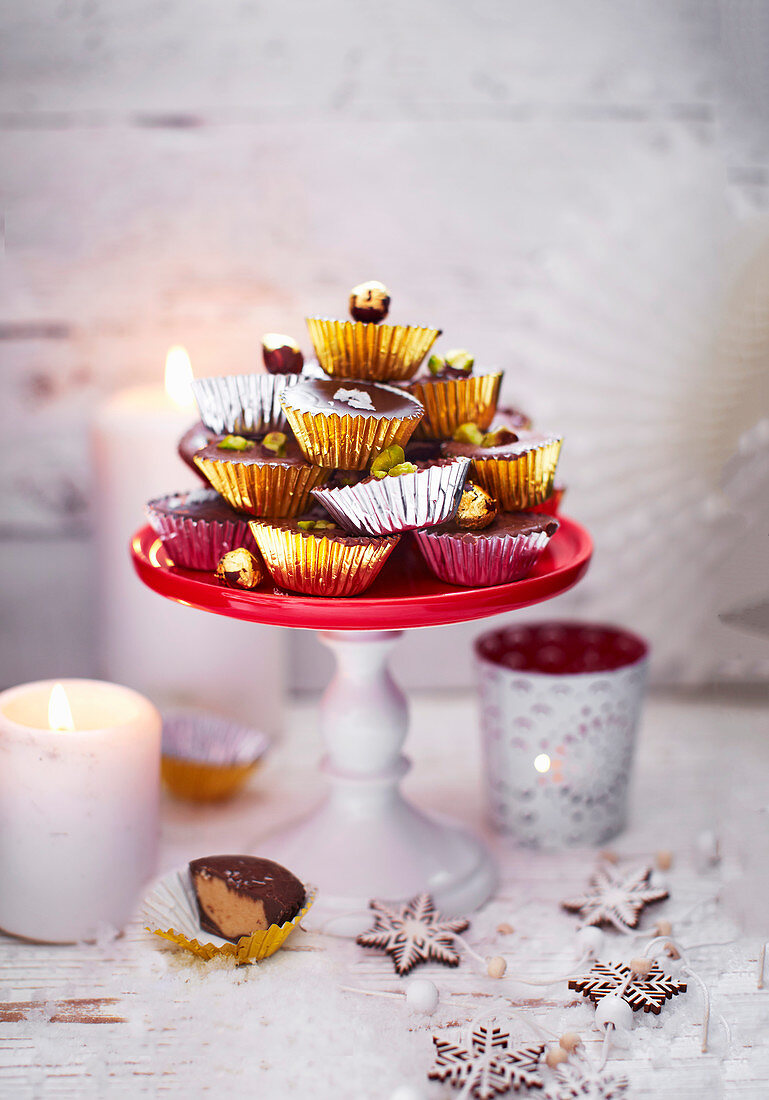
[163,710,271,765]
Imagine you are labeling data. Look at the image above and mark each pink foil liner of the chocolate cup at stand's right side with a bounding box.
[414,529,552,589]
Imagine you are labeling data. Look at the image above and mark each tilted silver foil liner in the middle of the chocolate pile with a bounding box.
[312,458,470,535]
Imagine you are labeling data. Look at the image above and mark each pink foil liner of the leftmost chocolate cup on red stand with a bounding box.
[145,490,261,572]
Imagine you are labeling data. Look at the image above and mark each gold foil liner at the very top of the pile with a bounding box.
[307,317,441,382]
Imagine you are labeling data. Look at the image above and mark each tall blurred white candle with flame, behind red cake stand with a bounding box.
[92,349,285,735]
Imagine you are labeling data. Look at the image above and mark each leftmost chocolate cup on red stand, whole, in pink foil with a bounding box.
[145,488,257,571]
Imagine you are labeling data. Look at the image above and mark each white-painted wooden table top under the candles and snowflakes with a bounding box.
[0,695,769,1100]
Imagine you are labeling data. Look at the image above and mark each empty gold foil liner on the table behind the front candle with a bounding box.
[161,708,270,802]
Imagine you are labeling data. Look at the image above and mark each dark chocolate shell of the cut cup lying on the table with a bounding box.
[189,856,306,942]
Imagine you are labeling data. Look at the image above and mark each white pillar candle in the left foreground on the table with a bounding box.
[0,680,161,943]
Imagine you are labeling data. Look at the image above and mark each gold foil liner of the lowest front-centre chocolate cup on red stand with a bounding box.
[251,519,399,597]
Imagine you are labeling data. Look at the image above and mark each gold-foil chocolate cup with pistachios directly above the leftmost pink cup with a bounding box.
[195,439,331,516]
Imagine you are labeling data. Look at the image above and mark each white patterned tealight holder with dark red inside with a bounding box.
[475,623,648,848]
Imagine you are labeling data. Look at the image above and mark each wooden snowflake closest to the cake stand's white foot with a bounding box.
[356,893,470,977]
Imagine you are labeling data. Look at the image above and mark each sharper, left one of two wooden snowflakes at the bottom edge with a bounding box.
[427,1024,545,1100]
